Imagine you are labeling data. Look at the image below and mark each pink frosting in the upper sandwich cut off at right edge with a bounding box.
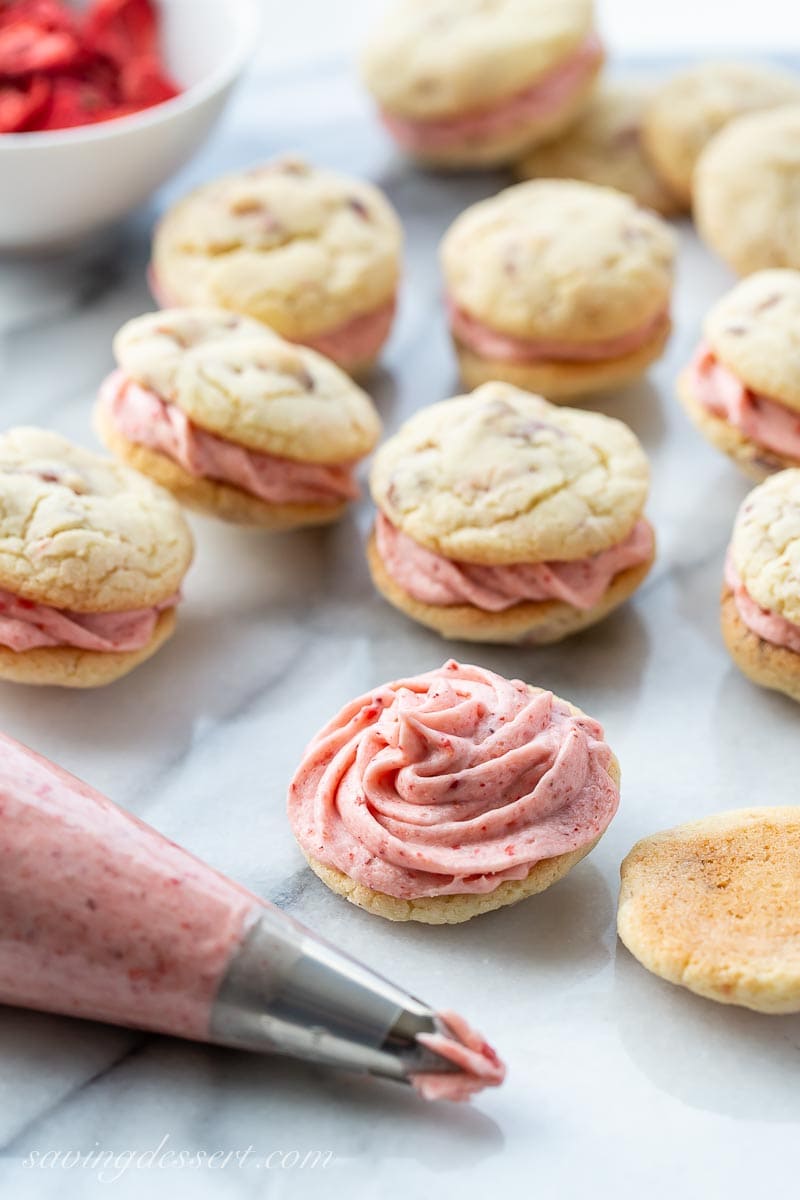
[690,342,800,460]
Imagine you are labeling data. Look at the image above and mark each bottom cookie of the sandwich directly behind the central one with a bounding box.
[453,317,672,403]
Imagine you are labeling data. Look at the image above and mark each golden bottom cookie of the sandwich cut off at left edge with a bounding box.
[0,608,175,688]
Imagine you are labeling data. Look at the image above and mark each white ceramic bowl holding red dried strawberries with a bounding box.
[0,0,260,252]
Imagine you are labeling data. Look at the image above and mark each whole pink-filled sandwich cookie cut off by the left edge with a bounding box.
[0,428,193,688]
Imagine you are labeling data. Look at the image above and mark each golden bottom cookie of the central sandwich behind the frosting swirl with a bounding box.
[367,530,655,646]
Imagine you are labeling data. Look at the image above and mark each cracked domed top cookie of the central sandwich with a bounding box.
[372,383,649,564]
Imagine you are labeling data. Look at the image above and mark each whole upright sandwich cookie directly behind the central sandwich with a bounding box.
[441,180,675,400]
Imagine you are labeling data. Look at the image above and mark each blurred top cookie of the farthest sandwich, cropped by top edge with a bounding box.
[361,0,594,120]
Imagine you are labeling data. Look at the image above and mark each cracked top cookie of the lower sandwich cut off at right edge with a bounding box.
[730,469,800,625]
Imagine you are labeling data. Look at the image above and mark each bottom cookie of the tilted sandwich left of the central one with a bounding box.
[95,406,347,530]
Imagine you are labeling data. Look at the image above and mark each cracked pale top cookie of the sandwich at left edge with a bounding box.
[0,428,193,612]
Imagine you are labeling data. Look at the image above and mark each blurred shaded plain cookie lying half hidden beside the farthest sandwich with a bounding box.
[517,80,684,216]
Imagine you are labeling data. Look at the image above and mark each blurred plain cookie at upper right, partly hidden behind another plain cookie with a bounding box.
[643,62,800,209]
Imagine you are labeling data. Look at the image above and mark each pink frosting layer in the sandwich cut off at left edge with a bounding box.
[0,590,180,652]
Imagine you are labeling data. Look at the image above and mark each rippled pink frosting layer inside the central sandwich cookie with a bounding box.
[375,512,654,612]
